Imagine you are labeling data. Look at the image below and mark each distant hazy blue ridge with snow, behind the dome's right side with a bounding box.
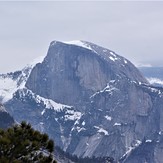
[139,67,163,87]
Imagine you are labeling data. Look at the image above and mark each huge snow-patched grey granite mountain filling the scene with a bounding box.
[0,41,163,162]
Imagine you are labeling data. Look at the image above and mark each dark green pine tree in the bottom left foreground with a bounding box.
[0,122,56,163]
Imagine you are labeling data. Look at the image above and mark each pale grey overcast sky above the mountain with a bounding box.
[0,1,163,73]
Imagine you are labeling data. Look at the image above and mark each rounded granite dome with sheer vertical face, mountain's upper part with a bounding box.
[26,41,147,106]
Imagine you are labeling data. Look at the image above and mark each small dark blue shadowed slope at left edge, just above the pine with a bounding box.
[0,103,14,129]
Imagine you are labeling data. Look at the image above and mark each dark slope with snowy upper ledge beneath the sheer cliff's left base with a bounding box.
[6,88,82,150]
